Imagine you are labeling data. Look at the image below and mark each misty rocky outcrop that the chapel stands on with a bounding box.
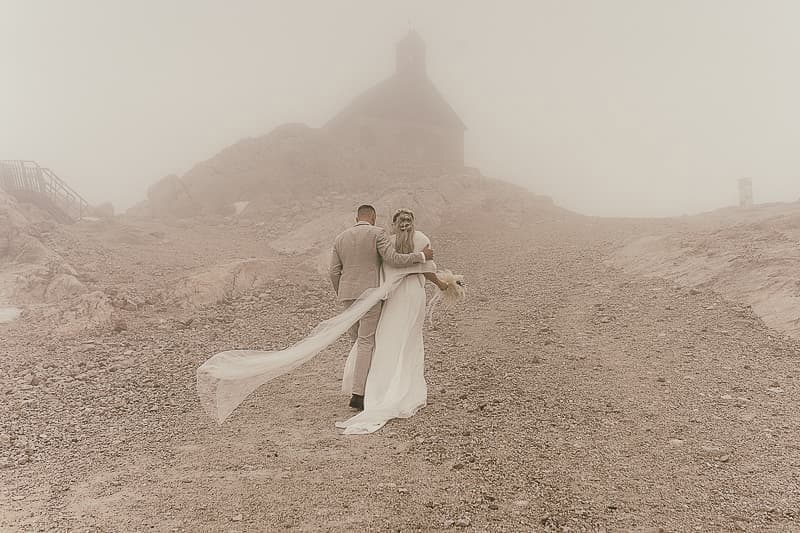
[130,124,564,219]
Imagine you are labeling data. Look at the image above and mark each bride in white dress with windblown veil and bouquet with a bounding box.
[197,209,464,434]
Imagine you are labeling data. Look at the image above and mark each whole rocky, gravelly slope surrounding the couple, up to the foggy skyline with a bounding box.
[0,128,800,531]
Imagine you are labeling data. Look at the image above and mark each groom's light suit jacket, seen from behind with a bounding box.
[329,222,425,301]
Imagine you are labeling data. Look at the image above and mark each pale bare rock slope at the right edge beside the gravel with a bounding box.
[615,203,800,337]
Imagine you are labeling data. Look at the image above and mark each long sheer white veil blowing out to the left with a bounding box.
[197,261,436,424]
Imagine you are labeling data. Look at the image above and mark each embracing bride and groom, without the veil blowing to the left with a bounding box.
[330,205,456,433]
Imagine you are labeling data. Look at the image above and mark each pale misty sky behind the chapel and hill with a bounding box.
[0,0,800,216]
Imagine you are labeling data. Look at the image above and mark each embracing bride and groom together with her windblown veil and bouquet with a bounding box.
[197,205,464,434]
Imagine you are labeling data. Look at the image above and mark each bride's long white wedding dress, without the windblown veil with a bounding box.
[336,231,430,435]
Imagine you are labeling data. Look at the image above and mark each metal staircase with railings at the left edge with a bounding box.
[0,160,89,223]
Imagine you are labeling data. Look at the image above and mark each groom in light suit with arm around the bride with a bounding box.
[330,205,433,411]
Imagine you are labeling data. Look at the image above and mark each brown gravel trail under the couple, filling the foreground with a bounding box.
[0,212,800,531]
